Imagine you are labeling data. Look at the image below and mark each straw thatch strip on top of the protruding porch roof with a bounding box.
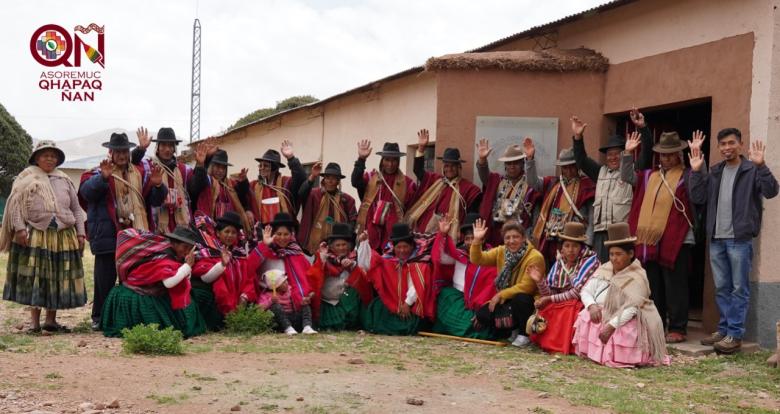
[425,48,609,72]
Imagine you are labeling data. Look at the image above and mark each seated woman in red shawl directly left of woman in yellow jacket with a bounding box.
[431,213,496,339]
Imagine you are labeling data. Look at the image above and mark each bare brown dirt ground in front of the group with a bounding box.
[0,302,598,414]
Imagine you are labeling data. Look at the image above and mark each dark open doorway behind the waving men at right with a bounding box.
[613,98,712,325]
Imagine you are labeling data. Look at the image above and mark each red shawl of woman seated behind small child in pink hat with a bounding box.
[246,243,313,309]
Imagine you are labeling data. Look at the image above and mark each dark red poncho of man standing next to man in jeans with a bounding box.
[628,170,695,269]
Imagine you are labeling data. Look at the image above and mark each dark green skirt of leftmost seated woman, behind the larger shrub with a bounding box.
[101,284,206,338]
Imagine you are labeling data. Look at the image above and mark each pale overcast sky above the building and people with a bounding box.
[0,0,605,140]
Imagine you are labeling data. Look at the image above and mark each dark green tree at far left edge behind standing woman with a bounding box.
[0,104,32,199]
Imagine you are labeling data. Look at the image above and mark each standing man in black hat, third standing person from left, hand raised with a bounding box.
[130,127,192,234]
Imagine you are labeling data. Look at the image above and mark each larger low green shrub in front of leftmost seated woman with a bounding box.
[122,323,184,355]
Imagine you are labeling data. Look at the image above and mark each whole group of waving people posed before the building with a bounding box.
[0,109,778,367]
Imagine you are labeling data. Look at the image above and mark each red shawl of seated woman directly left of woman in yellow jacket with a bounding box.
[432,234,497,310]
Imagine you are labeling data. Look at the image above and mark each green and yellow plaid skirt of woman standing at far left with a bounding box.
[3,227,87,309]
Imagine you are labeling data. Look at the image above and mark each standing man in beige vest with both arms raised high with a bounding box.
[571,108,653,263]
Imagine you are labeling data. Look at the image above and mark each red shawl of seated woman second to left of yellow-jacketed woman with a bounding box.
[366,250,436,320]
